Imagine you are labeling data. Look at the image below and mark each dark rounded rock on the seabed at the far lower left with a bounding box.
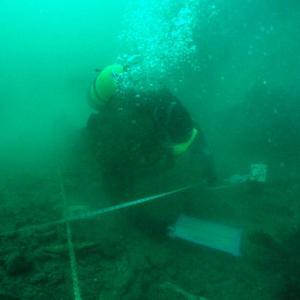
[5,252,33,276]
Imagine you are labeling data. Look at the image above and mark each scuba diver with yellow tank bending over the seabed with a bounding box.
[85,64,216,199]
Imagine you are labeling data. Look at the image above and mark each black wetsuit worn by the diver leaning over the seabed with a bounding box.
[87,90,216,199]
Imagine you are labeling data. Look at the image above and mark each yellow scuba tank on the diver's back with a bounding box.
[89,64,124,110]
